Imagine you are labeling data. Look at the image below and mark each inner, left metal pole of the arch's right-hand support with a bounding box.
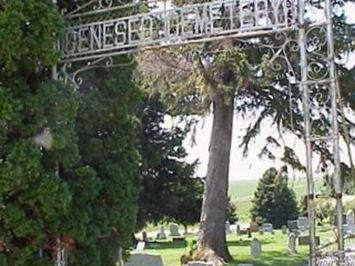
[298,0,316,266]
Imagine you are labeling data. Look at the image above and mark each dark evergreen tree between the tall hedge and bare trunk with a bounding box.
[138,96,203,229]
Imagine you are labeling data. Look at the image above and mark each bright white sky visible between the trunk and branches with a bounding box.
[184,4,355,180]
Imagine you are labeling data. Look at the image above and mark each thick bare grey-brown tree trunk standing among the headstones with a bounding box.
[198,92,234,261]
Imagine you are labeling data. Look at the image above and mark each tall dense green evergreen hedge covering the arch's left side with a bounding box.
[0,0,140,266]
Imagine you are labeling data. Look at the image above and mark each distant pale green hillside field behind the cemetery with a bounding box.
[229,179,322,221]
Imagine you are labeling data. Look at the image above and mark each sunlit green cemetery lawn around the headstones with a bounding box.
[147,230,331,266]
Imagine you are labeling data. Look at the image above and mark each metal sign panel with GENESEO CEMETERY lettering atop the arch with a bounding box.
[60,0,297,61]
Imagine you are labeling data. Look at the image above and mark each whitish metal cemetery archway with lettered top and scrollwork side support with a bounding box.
[54,0,349,266]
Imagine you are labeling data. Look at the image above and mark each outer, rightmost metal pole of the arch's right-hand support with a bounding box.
[325,0,345,266]
